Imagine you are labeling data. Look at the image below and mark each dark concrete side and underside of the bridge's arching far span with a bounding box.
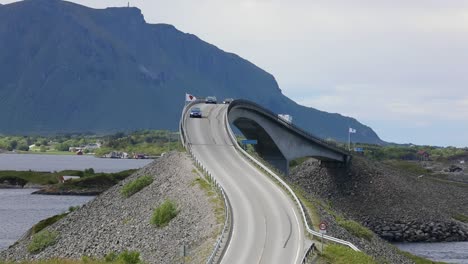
[227,100,351,174]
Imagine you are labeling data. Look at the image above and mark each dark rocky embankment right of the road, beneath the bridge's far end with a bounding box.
[289,157,468,242]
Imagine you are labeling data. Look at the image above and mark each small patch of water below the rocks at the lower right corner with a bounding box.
[395,242,468,264]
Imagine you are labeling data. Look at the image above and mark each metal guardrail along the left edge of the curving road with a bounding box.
[179,100,233,264]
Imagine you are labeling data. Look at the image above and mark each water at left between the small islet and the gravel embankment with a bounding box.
[0,189,94,249]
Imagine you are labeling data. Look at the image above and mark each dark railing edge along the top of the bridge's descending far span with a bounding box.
[228,99,351,156]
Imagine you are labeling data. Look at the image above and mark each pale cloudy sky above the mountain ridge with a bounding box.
[0,0,468,147]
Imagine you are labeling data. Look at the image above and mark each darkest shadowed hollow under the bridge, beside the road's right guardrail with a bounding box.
[233,117,289,175]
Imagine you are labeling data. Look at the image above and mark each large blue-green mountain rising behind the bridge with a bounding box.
[0,0,382,143]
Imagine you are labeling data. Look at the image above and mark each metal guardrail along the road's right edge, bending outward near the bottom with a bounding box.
[224,109,360,251]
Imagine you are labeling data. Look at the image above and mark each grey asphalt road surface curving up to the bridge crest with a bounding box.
[185,104,304,264]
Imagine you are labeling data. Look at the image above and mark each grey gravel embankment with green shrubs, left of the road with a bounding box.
[0,153,221,263]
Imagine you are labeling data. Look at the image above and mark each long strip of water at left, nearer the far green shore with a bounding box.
[0,154,153,172]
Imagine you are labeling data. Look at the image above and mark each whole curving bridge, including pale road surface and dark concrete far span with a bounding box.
[180,100,358,264]
